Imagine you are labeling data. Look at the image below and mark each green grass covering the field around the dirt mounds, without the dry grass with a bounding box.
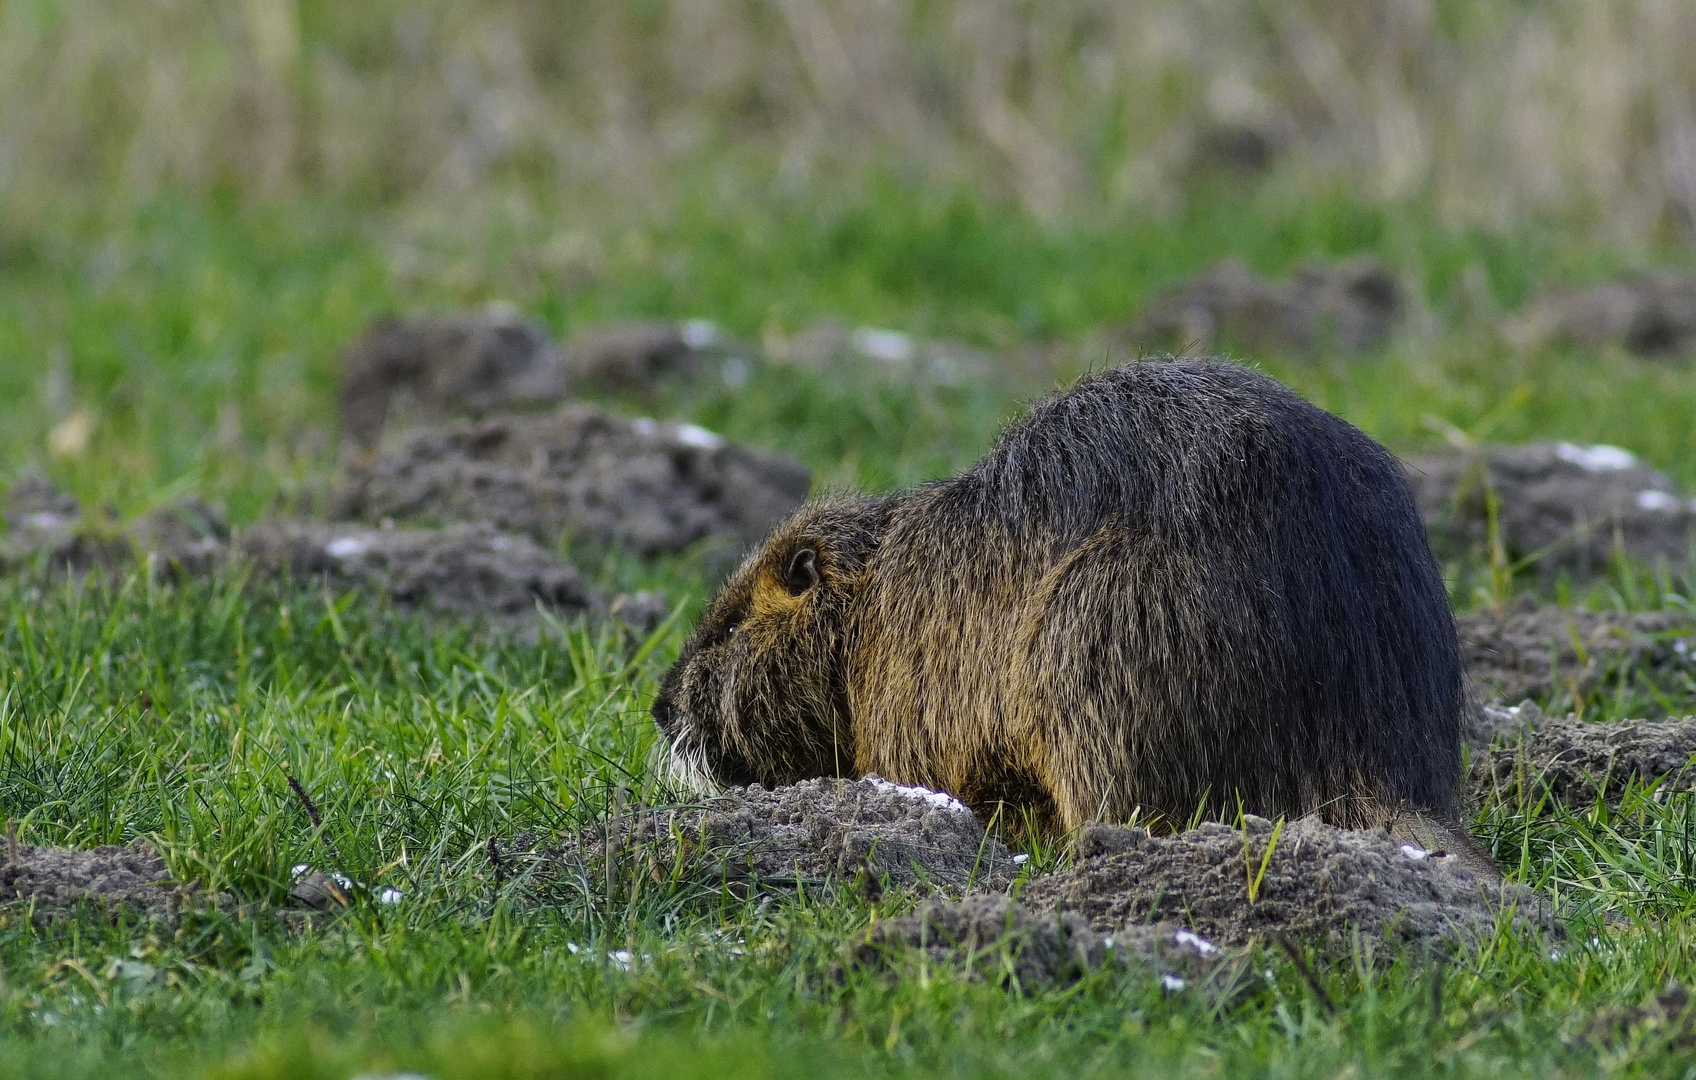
[0,183,1696,1078]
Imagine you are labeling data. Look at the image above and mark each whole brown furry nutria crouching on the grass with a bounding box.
[653,359,1464,831]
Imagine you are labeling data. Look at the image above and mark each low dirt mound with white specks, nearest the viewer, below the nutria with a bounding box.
[843,894,1241,990]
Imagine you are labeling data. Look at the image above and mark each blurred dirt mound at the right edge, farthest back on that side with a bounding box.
[1504,275,1696,358]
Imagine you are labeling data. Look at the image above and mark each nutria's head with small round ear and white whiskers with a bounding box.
[653,498,892,787]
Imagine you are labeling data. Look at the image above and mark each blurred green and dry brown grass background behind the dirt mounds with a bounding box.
[0,0,1696,519]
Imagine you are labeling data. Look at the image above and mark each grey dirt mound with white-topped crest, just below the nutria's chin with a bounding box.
[546,777,1018,894]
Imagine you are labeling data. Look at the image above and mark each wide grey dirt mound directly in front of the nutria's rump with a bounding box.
[1023,817,1560,948]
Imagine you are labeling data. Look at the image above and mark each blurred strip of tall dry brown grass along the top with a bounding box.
[0,0,1696,246]
